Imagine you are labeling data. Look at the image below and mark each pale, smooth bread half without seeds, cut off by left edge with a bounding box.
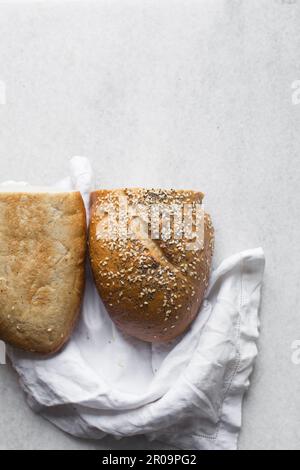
[0,189,86,355]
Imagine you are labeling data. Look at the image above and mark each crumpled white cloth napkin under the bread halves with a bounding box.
[9,157,264,450]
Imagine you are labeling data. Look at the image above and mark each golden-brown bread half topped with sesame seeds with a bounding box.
[89,189,214,342]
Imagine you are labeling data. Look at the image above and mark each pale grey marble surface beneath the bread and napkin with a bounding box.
[0,0,300,449]
